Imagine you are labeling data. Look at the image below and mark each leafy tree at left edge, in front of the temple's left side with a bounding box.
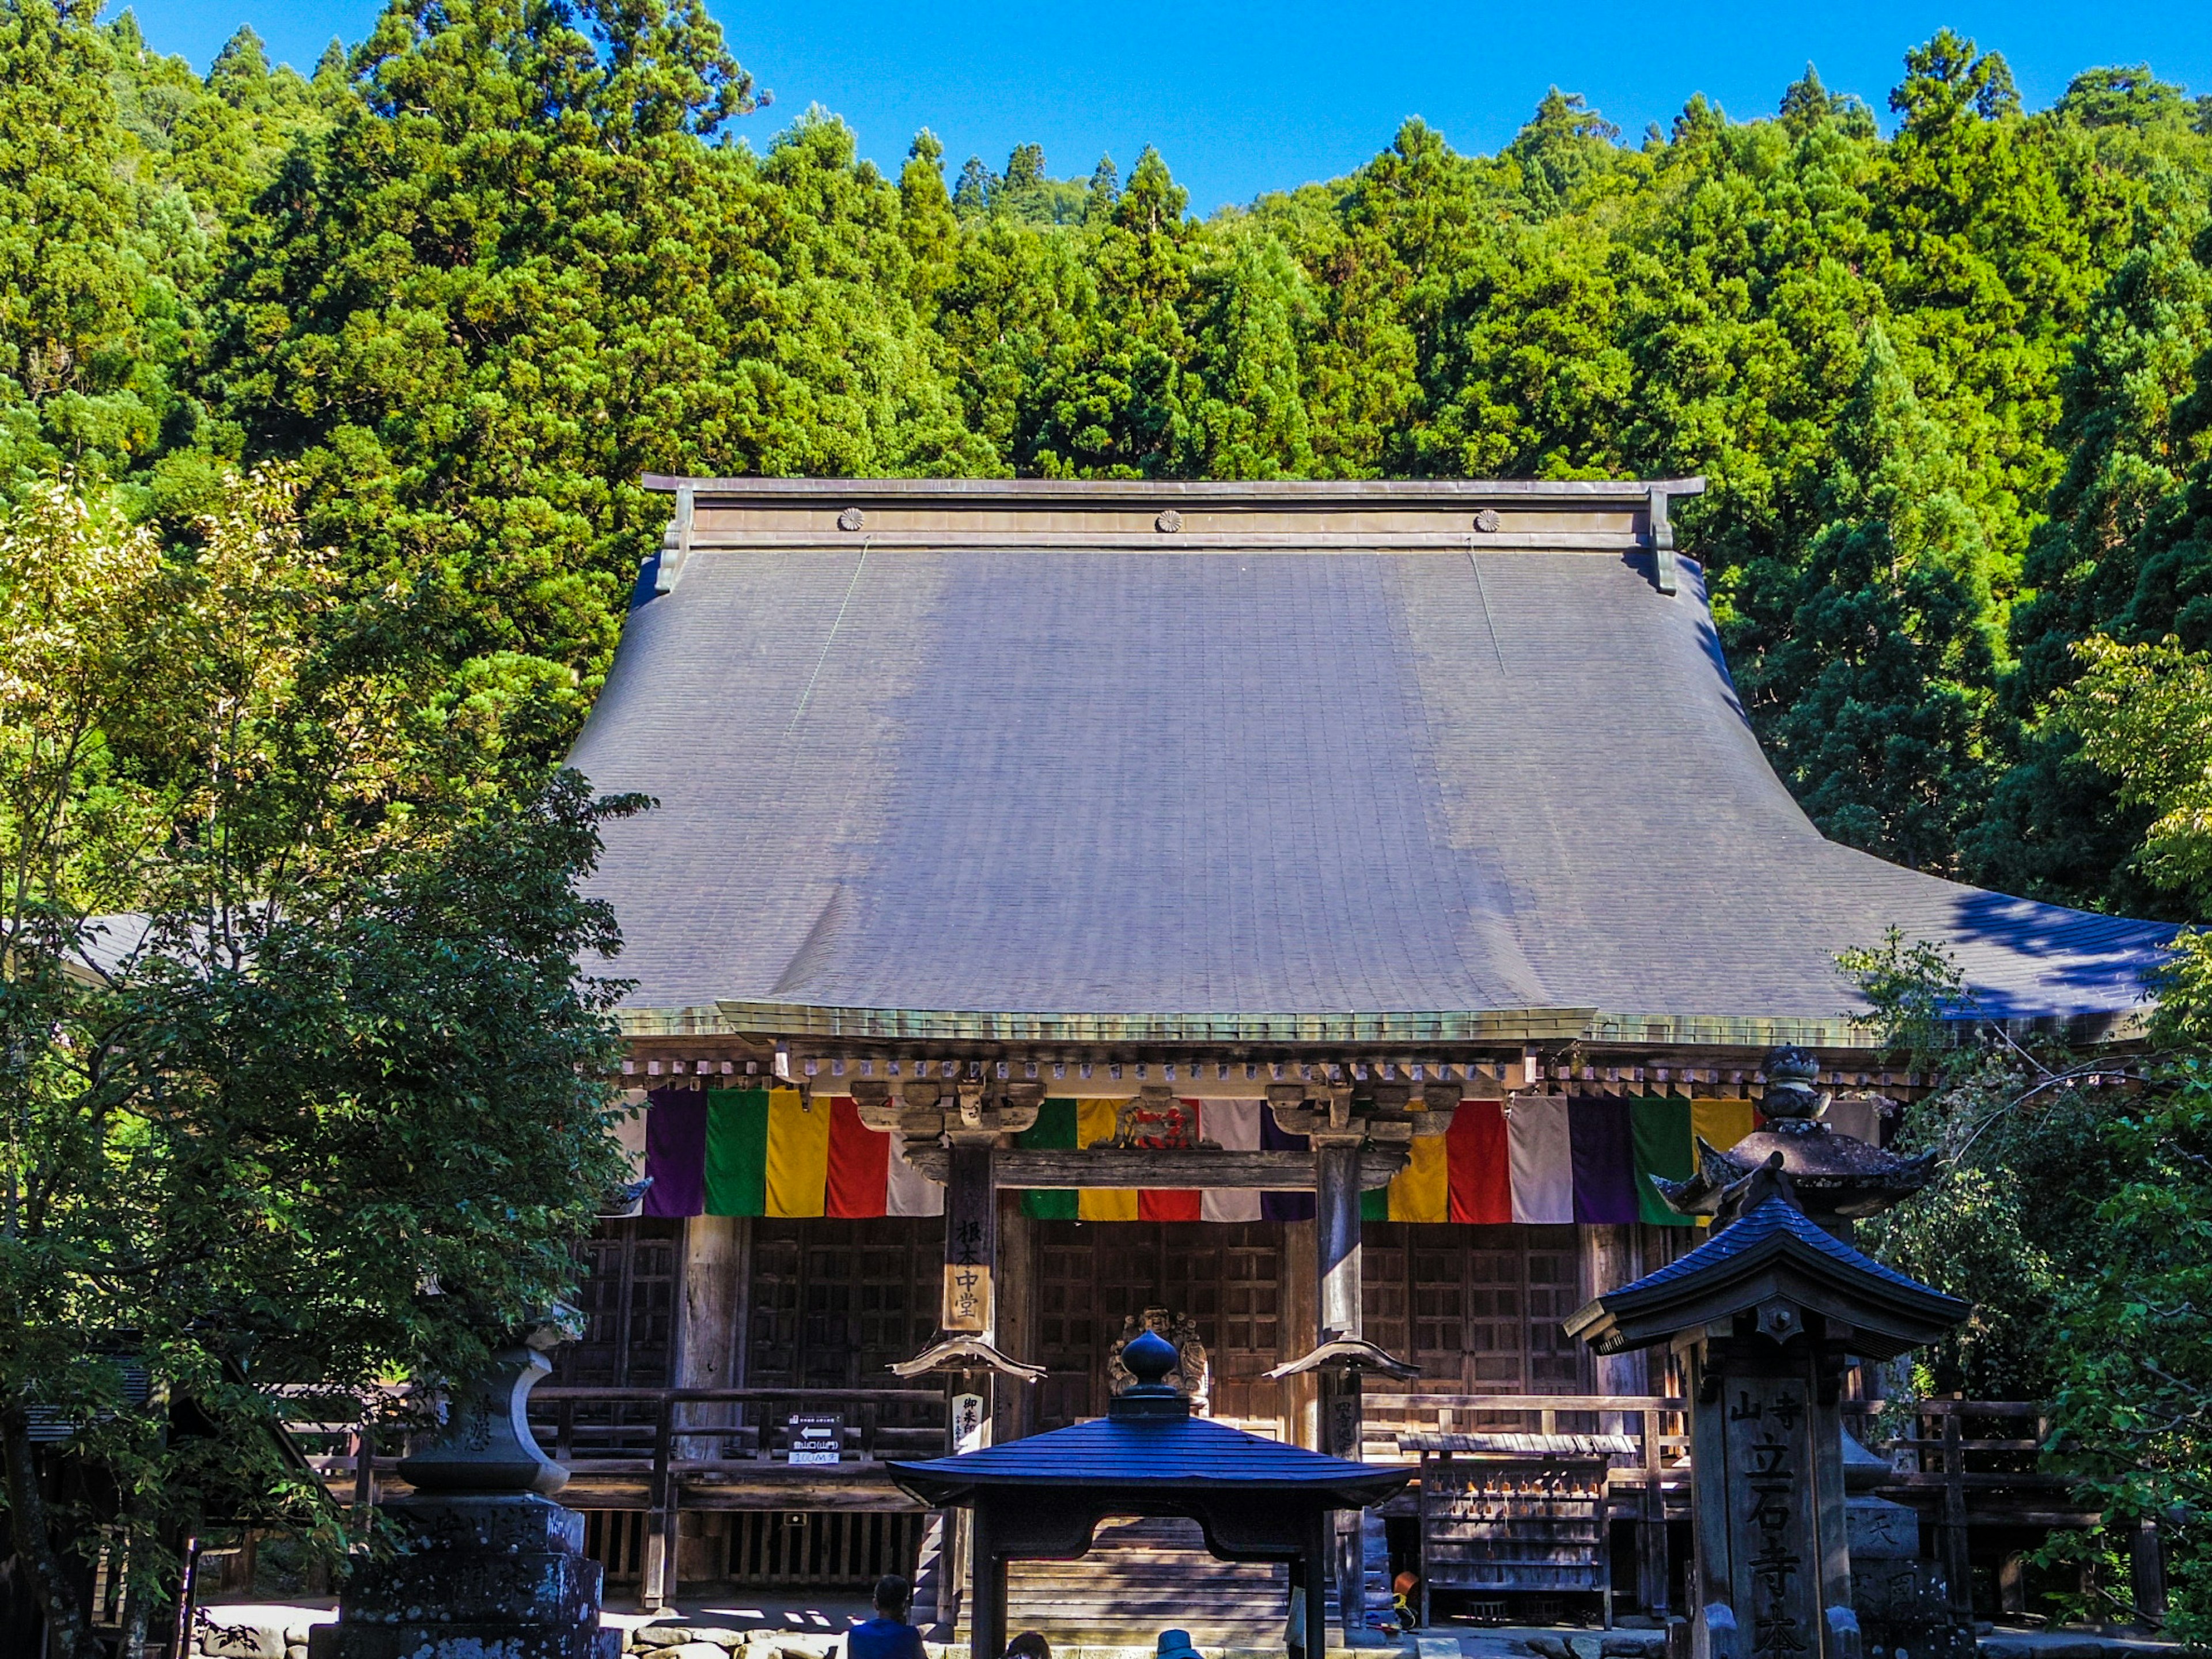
[0,478,635,1652]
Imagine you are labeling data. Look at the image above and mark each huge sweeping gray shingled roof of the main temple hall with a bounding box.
[573,484,2172,1040]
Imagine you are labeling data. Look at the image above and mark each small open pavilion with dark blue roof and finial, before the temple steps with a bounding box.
[892,1332,1411,1652]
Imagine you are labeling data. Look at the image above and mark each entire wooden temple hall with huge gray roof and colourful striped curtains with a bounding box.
[533,478,2170,1643]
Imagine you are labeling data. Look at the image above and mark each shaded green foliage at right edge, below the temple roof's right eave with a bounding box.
[1843,938,2212,1643]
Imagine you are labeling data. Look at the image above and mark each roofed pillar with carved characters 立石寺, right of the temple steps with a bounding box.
[1566,1153,1967,1659]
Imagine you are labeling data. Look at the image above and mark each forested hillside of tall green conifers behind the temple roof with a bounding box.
[13,0,2212,916]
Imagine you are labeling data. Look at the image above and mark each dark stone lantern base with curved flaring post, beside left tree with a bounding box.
[308,1320,622,1659]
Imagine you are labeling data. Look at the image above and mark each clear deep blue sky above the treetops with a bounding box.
[125,0,2212,213]
